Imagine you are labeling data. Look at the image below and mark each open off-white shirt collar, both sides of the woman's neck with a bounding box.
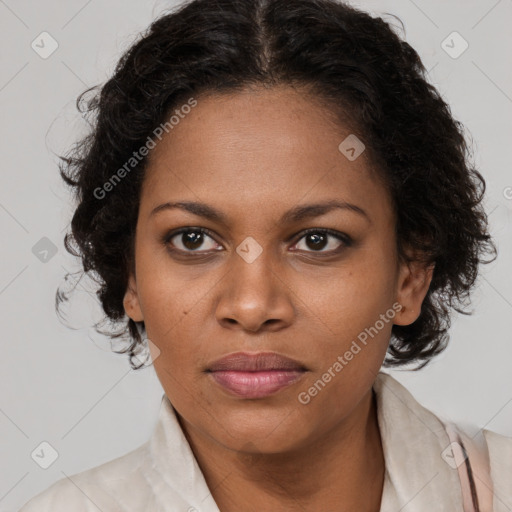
[145,371,462,512]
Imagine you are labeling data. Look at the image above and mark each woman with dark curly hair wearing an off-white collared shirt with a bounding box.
[18,0,512,512]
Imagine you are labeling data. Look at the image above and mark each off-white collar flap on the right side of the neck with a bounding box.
[373,372,462,512]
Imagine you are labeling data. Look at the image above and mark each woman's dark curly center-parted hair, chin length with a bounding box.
[56,0,497,370]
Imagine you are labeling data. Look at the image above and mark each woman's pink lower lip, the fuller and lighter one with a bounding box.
[210,370,304,398]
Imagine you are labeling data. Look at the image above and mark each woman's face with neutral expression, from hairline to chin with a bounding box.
[124,87,431,453]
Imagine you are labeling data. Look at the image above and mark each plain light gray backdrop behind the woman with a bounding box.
[0,0,512,512]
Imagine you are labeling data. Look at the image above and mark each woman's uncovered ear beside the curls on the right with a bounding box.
[393,260,435,325]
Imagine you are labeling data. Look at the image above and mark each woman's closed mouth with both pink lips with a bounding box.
[206,352,307,398]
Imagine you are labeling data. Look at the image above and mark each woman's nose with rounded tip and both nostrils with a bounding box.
[216,247,295,332]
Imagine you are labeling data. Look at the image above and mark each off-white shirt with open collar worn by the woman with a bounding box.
[20,372,512,512]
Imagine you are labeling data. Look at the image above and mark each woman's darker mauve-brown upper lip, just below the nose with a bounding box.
[207,352,306,372]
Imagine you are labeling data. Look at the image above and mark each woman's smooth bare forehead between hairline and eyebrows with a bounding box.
[141,87,389,225]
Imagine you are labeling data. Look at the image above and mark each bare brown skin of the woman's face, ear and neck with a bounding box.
[124,86,432,512]
